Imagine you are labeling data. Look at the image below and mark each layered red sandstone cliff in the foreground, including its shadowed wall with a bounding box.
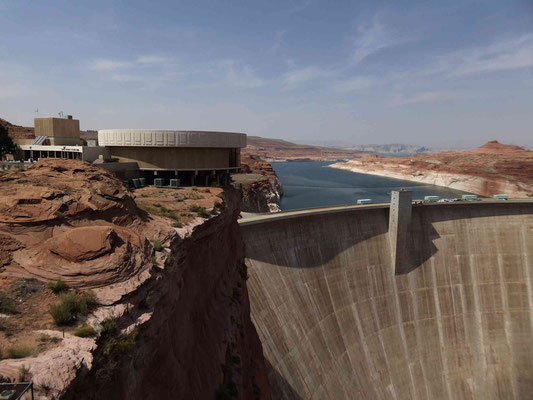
[0,160,270,400]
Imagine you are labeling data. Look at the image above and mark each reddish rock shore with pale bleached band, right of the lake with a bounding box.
[329,141,533,197]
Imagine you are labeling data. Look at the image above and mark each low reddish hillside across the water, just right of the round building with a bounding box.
[243,136,364,161]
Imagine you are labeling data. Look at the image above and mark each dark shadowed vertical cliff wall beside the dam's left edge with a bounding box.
[66,192,270,400]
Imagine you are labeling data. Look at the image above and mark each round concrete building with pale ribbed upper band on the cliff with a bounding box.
[98,129,246,183]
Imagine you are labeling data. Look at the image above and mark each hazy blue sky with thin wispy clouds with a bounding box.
[0,0,533,147]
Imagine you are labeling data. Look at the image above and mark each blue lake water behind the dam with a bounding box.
[271,161,472,211]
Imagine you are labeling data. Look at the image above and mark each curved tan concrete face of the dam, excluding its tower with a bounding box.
[241,203,533,399]
